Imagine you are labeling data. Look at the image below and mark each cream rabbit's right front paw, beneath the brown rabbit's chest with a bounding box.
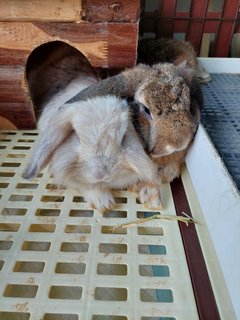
[139,183,163,209]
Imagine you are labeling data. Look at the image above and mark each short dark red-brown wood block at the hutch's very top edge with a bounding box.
[83,0,140,22]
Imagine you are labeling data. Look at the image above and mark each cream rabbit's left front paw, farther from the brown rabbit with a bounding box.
[85,191,115,212]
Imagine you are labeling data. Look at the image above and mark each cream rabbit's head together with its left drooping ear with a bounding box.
[24,96,141,184]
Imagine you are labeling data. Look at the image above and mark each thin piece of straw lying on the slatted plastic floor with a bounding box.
[111,212,198,233]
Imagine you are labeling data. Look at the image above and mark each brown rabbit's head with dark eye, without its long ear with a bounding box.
[130,63,196,156]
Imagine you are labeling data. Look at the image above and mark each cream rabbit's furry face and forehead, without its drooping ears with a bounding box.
[64,96,133,184]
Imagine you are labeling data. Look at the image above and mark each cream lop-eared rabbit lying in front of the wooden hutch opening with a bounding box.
[24,74,162,210]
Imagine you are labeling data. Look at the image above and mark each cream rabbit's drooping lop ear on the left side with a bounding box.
[23,113,72,179]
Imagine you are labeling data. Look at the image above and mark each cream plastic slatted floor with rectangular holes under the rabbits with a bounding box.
[0,131,198,320]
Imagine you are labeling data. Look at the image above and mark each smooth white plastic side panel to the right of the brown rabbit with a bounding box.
[186,126,240,319]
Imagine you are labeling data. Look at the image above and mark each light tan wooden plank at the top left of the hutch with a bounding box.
[0,0,82,21]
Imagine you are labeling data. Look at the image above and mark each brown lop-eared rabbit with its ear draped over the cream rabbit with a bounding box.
[64,40,202,182]
